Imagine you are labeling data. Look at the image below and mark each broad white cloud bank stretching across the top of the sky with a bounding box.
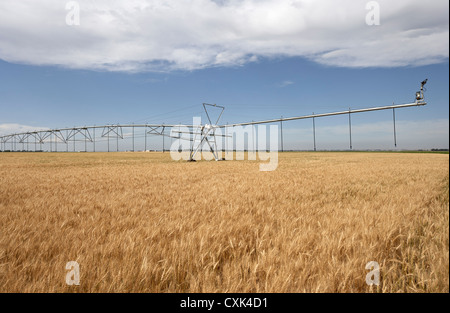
[0,0,449,71]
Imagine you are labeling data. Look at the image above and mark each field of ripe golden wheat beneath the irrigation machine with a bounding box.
[0,153,449,292]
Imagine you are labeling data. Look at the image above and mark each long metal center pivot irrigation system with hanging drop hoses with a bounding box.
[0,79,428,161]
